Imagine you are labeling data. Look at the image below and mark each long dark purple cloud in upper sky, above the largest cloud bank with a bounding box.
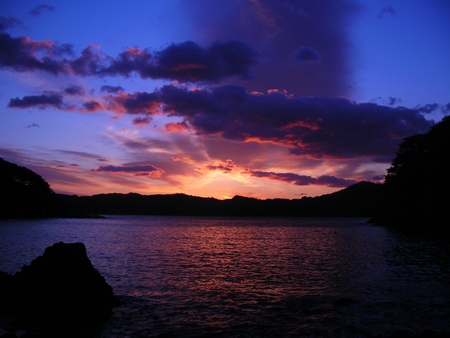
[74,41,259,83]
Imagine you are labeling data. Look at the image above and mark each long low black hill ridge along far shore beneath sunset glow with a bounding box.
[59,182,381,217]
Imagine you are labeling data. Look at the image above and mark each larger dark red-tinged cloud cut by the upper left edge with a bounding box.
[0,33,72,75]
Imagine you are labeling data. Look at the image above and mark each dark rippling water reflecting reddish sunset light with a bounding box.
[0,216,450,337]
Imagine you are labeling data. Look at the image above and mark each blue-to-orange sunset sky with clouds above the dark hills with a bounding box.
[0,0,450,199]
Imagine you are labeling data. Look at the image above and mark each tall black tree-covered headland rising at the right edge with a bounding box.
[384,116,450,227]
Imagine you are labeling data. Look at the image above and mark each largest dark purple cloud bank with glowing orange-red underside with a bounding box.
[117,85,433,158]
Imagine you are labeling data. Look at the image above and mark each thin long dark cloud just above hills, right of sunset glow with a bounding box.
[245,169,357,188]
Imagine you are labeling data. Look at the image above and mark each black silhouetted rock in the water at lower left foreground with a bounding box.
[0,242,115,337]
